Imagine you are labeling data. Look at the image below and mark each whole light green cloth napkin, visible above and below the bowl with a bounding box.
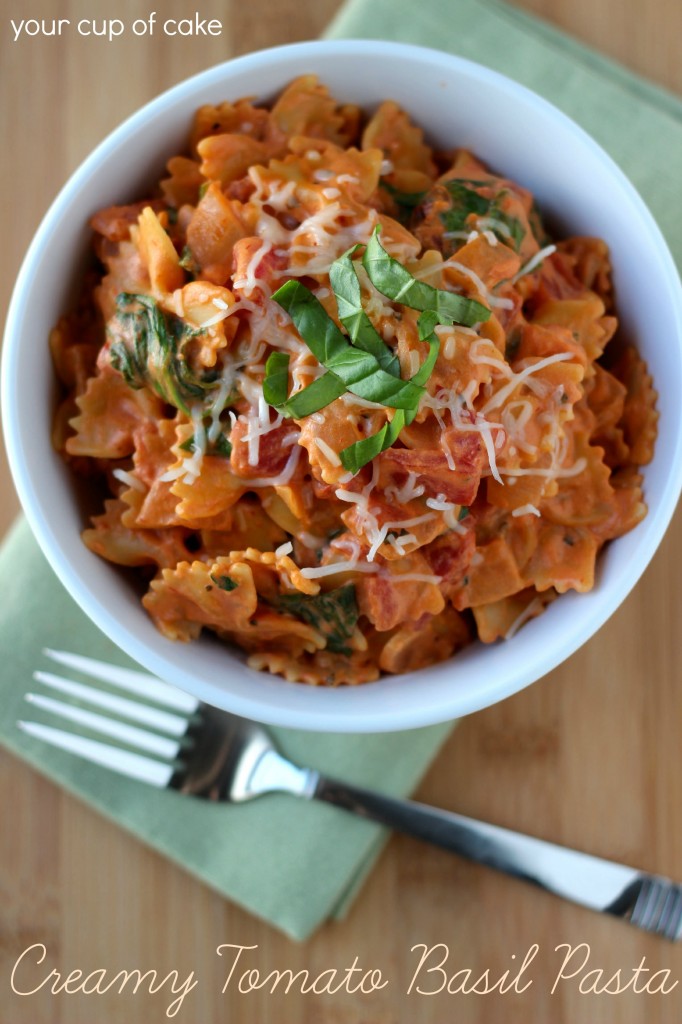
[0,0,682,939]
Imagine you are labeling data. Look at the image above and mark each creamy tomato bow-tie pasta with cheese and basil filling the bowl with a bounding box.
[51,76,656,685]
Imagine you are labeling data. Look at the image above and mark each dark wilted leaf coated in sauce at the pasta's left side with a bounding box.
[110,292,219,415]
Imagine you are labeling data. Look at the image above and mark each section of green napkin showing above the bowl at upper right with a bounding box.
[326,0,682,260]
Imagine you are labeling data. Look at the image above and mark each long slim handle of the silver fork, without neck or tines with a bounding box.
[312,776,682,938]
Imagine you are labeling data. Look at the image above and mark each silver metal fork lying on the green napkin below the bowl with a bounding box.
[18,650,682,940]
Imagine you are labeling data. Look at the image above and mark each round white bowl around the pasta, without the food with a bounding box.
[2,41,682,732]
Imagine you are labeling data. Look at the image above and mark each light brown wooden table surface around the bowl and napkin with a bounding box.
[0,0,682,1024]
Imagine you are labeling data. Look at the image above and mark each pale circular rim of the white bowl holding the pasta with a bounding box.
[0,39,682,732]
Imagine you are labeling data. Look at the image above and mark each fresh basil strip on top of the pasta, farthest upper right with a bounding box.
[363,228,491,327]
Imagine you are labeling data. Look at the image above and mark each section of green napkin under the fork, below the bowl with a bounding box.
[0,519,452,939]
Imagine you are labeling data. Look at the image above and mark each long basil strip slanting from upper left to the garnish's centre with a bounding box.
[272,281,423,409]
